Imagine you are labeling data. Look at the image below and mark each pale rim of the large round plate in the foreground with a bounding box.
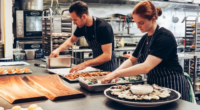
[104,88,181,107]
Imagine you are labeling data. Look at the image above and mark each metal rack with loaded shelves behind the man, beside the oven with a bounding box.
[42,9,73,56]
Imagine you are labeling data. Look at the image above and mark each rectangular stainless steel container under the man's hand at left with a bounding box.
[46,55,73,68]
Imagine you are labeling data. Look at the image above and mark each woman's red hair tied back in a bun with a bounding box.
[132,0,162,20]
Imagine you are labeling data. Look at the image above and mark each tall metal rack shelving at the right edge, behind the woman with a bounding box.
[184,16,200,95]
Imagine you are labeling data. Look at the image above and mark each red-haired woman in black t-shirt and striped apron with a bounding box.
[102,1,190,101]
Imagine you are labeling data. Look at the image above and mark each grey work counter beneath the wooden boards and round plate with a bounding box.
[0,60,200,110]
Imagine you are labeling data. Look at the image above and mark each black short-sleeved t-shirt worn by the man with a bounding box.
[74,18,114,50]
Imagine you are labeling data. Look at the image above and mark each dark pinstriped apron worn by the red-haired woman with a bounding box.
[137,25,190,101]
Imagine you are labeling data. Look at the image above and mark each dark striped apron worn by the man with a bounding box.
[85,17,117,71]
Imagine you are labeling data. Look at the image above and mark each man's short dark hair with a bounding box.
[69,1,88,18]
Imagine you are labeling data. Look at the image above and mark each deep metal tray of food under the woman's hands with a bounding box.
[79,76,144,92]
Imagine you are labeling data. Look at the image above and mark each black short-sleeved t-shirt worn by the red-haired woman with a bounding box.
[133,27,183,73]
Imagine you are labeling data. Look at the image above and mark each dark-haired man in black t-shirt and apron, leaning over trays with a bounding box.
[50,1,117,73]
